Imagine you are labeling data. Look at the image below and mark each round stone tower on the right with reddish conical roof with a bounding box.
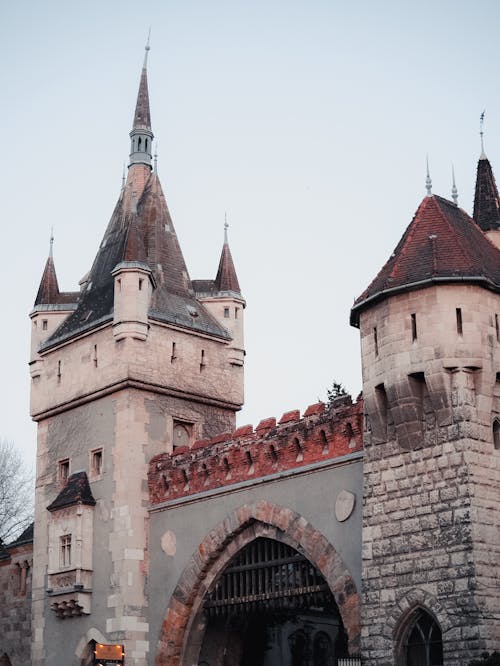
[351,184,500,666]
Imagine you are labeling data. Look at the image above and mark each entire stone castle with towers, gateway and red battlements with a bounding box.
[0,42,500,666]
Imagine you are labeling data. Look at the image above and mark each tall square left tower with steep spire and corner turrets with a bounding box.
[30,46,245,666]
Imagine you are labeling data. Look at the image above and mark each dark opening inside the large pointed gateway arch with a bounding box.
[198,537,347,666]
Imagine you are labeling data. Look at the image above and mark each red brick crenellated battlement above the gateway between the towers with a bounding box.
[148,396,363,504]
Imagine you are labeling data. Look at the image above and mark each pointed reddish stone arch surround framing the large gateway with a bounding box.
[155,500,360,666]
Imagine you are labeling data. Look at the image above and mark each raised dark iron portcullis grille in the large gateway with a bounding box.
[204,537,331,617]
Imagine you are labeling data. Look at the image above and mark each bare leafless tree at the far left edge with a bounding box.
[0,440,33,544]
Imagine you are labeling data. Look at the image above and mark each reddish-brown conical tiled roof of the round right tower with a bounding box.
[351,195,500,326]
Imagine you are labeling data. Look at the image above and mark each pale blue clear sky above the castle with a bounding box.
[0,0,500,465]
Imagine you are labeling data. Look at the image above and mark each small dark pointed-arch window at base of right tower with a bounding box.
[402,608,443,666]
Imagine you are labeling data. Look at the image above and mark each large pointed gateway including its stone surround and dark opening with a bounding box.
[156,502,359,666]
